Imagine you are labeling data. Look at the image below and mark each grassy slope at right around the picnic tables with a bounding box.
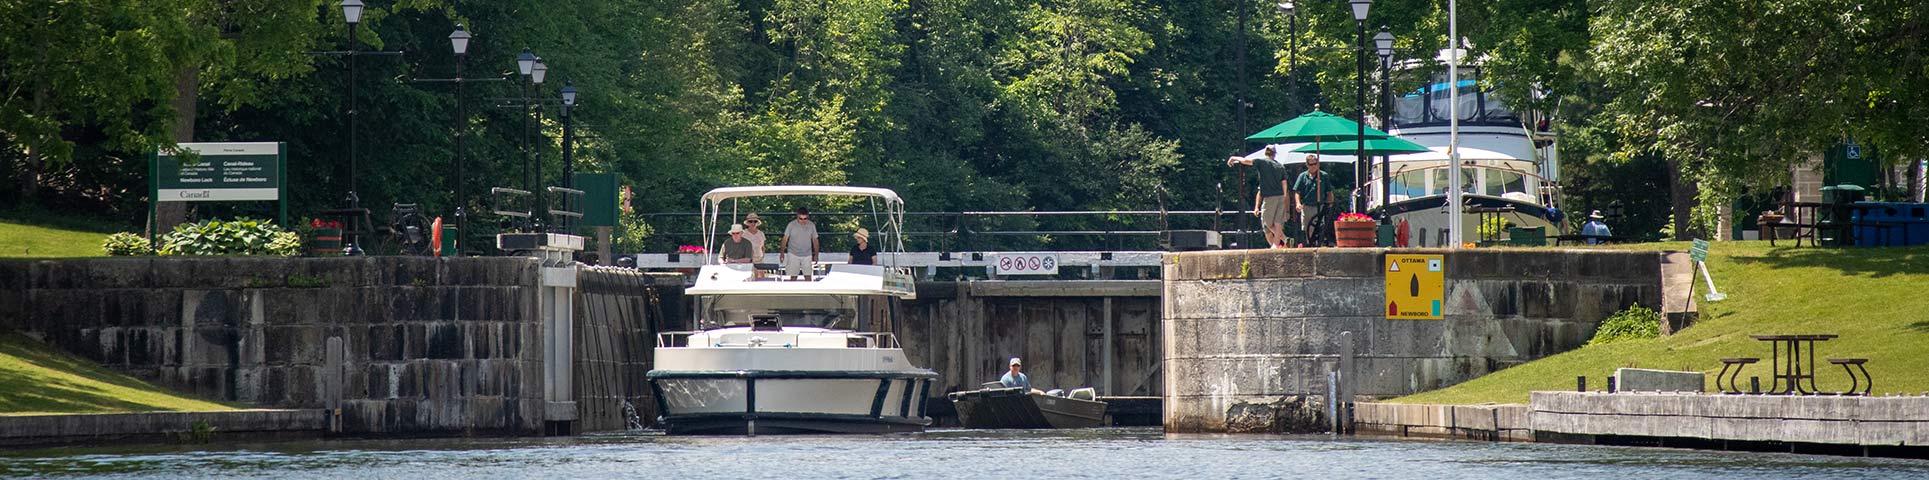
[1393,241,1929,405]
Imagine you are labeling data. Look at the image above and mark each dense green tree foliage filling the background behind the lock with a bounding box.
[0,0,1929,249]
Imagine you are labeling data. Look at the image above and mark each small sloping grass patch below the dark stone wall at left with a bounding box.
[0,332,233,414]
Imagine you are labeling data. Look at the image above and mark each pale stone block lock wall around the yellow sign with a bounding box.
[1163,249,1661,432]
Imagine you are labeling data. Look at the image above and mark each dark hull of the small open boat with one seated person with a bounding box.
[947,387,1105,428]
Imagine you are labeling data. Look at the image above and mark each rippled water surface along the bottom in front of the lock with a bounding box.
[0,428,1929,480]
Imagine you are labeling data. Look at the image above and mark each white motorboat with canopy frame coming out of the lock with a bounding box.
[648,187,937,436]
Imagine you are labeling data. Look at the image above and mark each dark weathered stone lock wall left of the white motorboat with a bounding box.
[0,256,542,434]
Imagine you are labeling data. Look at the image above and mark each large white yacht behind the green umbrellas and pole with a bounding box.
[1368,50,1561,247]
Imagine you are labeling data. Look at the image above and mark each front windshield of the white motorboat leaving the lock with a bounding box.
[698,295,866,330]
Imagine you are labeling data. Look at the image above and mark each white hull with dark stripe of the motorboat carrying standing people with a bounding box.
[648,370,937,436]
